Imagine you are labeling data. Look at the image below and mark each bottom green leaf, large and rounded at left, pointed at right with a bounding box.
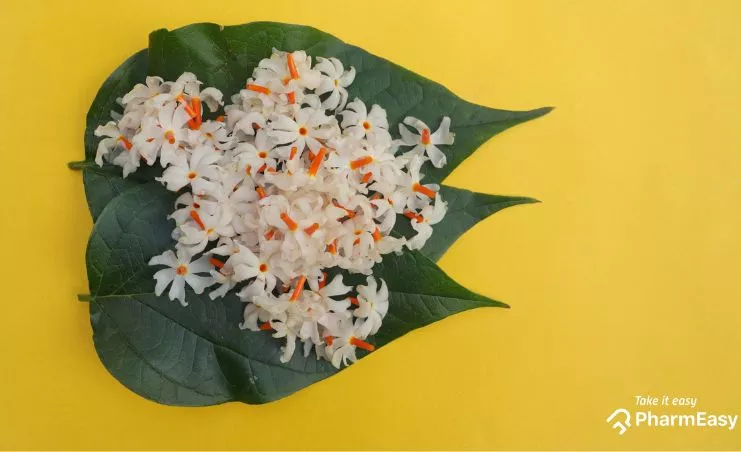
[87,183,506,405]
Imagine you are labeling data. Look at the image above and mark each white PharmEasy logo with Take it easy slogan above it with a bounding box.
[607,395,738,435]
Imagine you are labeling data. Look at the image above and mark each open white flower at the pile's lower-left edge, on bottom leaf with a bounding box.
[149,249,213,306]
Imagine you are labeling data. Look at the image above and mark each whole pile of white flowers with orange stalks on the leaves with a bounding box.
[95,50,453,368]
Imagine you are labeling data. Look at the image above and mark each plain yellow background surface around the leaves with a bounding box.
[0,0,741,449]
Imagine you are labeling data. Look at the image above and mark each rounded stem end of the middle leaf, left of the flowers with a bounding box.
[80,49,148,221]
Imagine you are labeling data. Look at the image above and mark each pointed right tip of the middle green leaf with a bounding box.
[394,185,539,261]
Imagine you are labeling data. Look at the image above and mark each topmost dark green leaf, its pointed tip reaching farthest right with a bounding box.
[149,22,551,183]
